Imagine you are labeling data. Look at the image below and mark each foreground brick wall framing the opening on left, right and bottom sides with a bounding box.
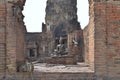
[0,0,120,80]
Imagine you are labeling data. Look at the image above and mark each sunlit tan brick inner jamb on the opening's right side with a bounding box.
[22,0,94,70]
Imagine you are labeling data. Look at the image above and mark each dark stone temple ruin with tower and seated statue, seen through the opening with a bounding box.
[26,0,83,64]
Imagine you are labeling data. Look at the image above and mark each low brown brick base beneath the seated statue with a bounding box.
[46,56,77,65]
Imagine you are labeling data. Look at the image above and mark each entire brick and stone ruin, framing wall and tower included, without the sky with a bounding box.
[0,0,120,80]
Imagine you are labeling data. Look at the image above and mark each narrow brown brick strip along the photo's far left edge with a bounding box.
[0,0,6,77]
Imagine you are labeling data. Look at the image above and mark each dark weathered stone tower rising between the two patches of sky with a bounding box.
[45,0,80,36]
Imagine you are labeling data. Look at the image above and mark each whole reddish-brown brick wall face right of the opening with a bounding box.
[94,0,120,77]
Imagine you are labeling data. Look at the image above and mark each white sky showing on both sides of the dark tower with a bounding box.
[23,0,89,32]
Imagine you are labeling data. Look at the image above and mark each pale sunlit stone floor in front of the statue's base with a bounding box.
[34,63,93,73]
